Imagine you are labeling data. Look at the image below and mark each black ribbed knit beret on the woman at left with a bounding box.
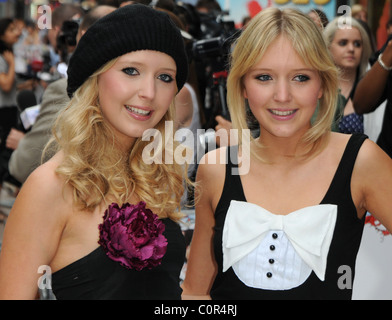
[67,4,188,97]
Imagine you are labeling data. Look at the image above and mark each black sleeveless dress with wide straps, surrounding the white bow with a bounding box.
[210,134,367,300]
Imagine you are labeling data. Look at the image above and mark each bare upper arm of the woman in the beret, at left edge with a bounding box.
[0,166,65,300]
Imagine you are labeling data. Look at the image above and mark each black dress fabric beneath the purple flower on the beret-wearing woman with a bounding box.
[52,219,185,300]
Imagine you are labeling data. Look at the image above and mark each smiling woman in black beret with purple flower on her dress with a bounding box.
[0,4,187,299]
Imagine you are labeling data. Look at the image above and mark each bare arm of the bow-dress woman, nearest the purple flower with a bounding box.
[182,151,225,299]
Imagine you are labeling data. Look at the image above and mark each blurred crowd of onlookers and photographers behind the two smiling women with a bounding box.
[0,0,392,300]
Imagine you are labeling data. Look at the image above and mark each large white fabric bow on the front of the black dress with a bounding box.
[222,200,337,281]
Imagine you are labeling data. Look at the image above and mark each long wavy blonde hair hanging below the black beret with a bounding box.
[45,59,190,221]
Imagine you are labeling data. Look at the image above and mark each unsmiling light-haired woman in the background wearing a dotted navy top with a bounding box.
[324,18,372,134]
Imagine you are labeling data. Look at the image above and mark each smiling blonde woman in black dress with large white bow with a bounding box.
[183,8,392,299]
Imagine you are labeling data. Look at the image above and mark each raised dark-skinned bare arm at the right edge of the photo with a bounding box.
[353,40,392,114]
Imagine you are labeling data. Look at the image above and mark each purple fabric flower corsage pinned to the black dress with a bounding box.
[98,202,167,271]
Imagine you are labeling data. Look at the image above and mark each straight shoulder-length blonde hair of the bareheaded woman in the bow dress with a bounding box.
[227,8,338,162]
